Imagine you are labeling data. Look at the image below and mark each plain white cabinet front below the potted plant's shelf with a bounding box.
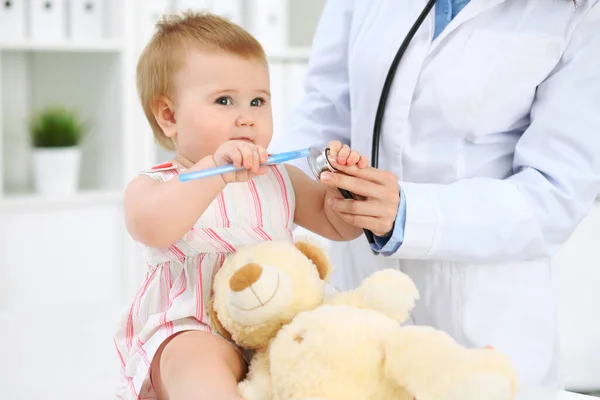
[0,205,123,400]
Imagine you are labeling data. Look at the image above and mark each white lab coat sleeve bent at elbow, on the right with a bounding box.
[384,4,600,262]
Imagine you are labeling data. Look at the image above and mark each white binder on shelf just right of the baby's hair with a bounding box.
[247,0,289,53]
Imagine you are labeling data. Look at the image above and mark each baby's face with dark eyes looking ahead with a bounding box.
[173,50,273,163]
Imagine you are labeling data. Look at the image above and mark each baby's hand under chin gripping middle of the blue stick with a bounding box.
[213,140,268,183]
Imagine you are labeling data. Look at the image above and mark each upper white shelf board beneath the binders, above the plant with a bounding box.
[0,40,123,53]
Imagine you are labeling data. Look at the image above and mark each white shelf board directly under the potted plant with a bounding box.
[1,190,123,213]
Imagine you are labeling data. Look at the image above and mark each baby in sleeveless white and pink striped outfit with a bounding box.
[115,9,368,400]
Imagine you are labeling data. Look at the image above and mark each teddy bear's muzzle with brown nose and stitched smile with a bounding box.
[228,263,293,326]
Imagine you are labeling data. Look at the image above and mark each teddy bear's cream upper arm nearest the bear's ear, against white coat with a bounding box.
[324,269,419,322]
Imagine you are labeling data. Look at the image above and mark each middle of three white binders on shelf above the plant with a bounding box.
[29,0,67,42]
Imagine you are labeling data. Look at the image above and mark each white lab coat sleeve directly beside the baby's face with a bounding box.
[284,0,354,176]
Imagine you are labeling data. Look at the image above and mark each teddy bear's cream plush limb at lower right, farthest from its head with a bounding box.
[382,326,517,400]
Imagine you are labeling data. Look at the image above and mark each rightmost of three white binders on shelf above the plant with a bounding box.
[68,0,107,41]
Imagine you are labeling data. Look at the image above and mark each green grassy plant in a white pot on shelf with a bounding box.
[29,107,87,195]
